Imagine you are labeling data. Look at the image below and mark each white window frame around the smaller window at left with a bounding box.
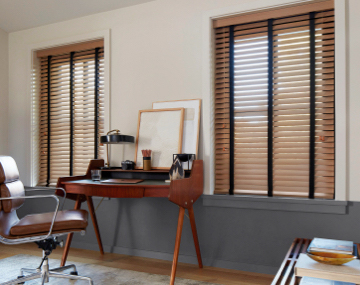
[28,30,110,186]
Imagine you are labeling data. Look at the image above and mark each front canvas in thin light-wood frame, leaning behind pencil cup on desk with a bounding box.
[135,108,185,169]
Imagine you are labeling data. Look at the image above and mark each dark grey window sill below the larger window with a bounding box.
[202,195,348,215]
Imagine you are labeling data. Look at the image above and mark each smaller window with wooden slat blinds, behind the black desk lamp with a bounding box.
[36,40,104,186]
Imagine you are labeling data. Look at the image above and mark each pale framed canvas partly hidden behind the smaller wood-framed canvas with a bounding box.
[153,99,201,169]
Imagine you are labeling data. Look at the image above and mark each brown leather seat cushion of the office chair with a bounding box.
[10,210,88,237]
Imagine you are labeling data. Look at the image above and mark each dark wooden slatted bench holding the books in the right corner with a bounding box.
[271,238,360,285]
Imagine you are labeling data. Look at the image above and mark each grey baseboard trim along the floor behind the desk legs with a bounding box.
[69,241,278,275]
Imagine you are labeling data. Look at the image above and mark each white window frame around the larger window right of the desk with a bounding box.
[202,0,349,201]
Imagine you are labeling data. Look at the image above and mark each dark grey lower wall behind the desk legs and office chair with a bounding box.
[18,196,360,274]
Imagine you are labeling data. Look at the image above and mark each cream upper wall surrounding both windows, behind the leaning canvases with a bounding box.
[9,0,360,201]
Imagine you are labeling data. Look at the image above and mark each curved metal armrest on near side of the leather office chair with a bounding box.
[0,195,60,244]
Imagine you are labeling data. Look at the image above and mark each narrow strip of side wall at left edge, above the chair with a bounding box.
[0,29,9,155]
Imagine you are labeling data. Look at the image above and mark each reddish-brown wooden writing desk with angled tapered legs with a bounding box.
[57,159,203,284]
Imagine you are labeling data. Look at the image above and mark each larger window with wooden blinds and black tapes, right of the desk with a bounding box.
[214,1,335,199]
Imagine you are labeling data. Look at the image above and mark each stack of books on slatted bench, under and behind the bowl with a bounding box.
[295,238,360,285]
